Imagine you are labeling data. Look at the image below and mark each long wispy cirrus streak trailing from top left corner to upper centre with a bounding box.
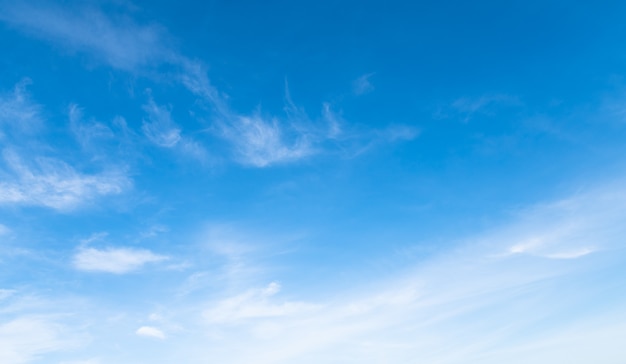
[0,2,417,168]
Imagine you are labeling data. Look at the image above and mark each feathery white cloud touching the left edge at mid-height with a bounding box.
[0,150,131,210]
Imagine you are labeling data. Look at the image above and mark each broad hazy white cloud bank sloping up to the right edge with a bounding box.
[165,186,626,364]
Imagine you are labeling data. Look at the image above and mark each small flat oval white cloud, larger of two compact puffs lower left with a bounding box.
[73,248,167,274]
